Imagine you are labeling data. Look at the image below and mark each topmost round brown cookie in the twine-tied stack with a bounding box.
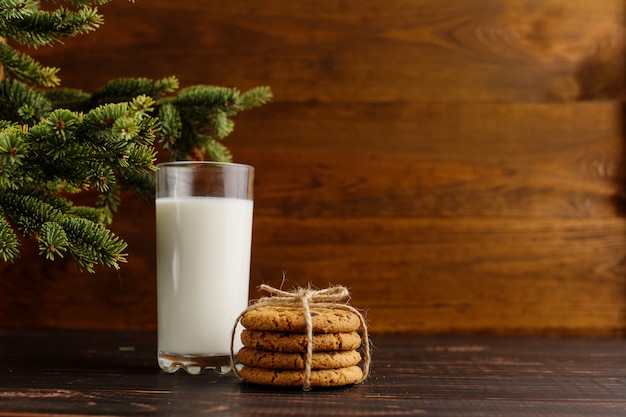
[241,306,361,333]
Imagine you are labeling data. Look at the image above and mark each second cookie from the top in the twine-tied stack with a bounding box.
[241,329,361,352]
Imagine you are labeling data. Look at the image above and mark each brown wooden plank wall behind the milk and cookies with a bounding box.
[0,0,626,336]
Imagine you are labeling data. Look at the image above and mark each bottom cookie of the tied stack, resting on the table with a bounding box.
[239,366,363,387]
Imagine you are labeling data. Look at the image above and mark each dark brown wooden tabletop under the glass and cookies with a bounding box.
[0,330,626,417]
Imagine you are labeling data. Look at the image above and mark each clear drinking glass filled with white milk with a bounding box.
[156,161,254,375]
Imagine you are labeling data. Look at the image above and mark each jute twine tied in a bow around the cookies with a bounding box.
[230,284,372,391]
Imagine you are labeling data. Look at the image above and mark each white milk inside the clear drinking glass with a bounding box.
[156,197,253,356]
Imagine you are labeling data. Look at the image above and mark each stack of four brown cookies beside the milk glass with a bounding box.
[237,306,363,387]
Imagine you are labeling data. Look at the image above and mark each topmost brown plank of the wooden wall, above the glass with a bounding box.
[22,0,624,102]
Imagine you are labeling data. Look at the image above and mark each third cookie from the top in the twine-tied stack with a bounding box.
[237,347,361,369]
